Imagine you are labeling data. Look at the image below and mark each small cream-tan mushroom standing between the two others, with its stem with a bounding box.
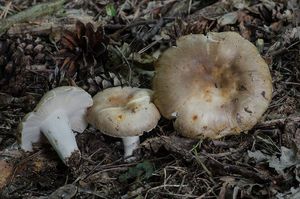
[87,87,160,158]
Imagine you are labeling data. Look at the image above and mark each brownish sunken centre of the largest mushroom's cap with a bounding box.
[185,60,241,106]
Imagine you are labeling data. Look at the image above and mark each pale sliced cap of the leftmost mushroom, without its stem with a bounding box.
[18,86,93,151]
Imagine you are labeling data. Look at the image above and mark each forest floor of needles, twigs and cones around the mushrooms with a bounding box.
[0,0,300,199]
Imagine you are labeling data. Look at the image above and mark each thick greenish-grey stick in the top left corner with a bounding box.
[0,0,65,36]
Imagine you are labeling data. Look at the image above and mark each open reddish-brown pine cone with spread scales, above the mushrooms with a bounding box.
[58,21,109,77]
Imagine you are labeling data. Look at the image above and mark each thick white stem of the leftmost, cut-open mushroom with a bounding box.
[41,110,79,164]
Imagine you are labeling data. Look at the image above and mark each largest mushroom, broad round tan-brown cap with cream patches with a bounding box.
[153,32,272,138]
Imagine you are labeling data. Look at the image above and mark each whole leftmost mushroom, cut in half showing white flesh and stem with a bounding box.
[18,86,93,165]
